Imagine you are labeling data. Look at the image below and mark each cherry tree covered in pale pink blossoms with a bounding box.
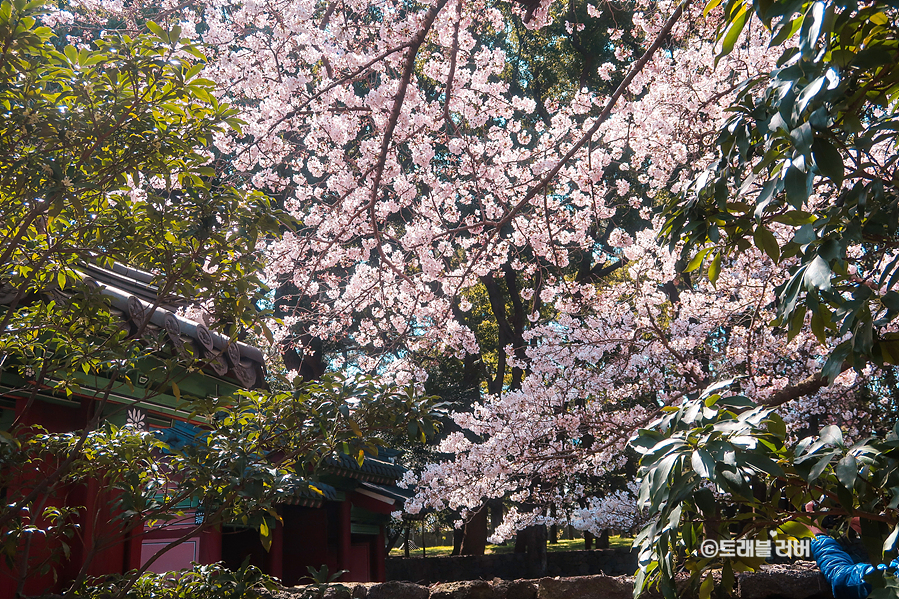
[58,0,899,576]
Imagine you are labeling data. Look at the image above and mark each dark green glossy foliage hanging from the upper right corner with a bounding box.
[663,0,899,379]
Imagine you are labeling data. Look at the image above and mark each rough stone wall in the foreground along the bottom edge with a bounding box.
[277,562,833,599]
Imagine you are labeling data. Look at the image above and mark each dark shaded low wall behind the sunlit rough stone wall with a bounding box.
[387,549,637,584]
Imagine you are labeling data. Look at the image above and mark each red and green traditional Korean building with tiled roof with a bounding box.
[0,265,405,597]
